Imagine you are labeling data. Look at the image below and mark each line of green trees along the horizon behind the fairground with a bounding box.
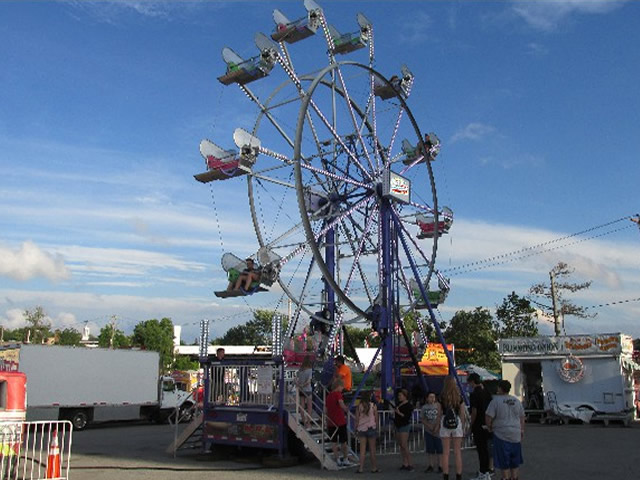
[0,262,591,370]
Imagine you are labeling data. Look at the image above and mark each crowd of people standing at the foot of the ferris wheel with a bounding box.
[297,356,524,480]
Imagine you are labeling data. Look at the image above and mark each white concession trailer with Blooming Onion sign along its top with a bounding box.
[498,333,640,423]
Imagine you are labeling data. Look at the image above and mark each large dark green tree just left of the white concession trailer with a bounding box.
[444,307,500,370]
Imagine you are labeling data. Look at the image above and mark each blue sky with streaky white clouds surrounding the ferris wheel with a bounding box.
[0,0,640,341]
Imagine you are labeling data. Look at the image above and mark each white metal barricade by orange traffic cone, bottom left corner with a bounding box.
[0,421,73,480]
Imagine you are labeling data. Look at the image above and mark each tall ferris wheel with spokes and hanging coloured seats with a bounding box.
[195,0,453,394]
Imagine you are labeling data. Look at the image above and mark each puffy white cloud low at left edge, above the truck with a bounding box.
[0,241,70,281]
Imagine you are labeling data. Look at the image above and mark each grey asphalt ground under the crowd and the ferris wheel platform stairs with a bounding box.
[69,423,640,480]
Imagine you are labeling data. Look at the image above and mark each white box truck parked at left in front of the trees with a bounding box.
[0,344,194,430]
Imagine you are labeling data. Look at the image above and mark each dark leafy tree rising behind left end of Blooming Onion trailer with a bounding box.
[494,292,538,338]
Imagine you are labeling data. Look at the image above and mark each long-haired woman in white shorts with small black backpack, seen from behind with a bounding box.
[440,375,466,480]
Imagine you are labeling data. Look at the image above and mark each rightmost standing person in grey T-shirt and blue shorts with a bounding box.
[486,380,524,480]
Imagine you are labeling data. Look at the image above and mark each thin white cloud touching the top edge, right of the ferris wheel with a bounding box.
[511,0,625,31]
